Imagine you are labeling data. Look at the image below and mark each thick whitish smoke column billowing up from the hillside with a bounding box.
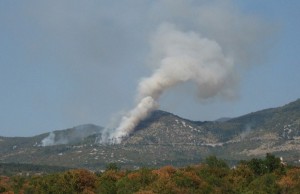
[109,23,236,143]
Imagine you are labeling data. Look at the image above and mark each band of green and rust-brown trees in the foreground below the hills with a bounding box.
[0,154,300,194]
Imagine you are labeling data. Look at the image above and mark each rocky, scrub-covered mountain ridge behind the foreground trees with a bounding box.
[0,100,300,170]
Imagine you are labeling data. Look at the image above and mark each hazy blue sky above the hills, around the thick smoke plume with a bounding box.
[0,0,300,136]
